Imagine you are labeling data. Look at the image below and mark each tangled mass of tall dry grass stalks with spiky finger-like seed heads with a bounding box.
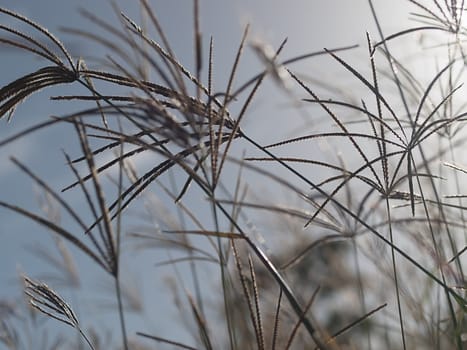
[0,0,467,349]
